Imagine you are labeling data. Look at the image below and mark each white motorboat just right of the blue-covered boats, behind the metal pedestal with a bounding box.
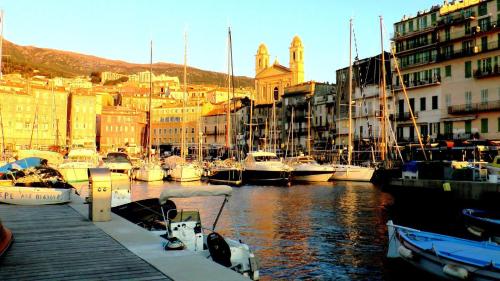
[58,148,99,182]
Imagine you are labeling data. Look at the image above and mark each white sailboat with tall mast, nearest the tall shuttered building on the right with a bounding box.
[332,19,375,181]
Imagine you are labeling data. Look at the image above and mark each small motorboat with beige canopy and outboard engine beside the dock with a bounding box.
[111,186,259,280]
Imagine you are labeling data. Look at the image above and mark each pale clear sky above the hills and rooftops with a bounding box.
[0,0,442,82]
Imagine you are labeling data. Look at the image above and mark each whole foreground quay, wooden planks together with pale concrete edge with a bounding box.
[0,191,245,281]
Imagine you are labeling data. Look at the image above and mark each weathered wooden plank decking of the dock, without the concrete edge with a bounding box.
[0,204,171,280]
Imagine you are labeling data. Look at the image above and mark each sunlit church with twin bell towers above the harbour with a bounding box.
[255,36,304,105]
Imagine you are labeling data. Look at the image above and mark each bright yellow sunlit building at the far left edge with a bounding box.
[0,77,68,150]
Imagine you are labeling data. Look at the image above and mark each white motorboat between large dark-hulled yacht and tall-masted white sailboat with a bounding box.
[286,156,334,182]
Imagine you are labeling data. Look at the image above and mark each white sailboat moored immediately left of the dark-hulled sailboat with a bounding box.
[170,33,203,182]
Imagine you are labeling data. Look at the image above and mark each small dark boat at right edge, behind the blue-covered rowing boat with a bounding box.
[462,209,500,243]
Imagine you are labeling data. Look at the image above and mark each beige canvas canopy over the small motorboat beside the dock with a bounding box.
[159,185,233,204]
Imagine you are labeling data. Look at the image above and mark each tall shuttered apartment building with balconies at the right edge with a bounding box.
[392,0,500,141]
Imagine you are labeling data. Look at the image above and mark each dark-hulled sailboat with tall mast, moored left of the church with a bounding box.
[208,28,243,185]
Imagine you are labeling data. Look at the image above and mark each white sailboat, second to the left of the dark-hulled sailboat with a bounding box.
[134,41,165,182]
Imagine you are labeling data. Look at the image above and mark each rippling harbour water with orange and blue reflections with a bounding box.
[75,179,472,280]
